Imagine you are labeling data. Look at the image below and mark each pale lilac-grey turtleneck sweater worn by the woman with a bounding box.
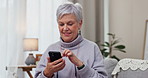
[35,35,108,78]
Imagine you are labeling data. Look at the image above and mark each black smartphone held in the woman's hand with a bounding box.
[48,51,62,62]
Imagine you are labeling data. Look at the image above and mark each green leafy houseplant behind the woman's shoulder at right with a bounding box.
[97,33,126,61]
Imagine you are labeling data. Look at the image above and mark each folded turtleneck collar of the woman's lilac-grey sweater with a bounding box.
[60,35,83,48]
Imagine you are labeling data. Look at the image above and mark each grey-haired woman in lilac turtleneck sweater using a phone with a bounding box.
[35,3,107,78]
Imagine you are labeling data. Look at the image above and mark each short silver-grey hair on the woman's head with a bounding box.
[56,2,83,22]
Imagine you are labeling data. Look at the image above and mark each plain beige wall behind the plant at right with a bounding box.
[109,0,148,59]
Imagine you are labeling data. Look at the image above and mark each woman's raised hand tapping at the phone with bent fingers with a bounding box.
[63,49,83,67]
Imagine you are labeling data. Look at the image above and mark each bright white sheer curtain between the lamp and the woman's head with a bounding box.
[26,0,68,53]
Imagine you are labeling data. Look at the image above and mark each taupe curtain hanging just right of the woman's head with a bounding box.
[74,0,104,43]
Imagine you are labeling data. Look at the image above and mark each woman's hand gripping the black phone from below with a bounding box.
[44,57,65,78]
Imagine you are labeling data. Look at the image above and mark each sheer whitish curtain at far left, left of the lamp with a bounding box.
[0,0,25,78]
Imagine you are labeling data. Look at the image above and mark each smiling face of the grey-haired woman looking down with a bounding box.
[58,14,82,42]
